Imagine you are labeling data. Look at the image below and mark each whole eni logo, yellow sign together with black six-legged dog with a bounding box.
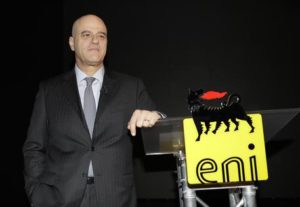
[183,89,268,185]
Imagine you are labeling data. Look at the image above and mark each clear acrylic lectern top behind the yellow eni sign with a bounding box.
[142,108,300,155]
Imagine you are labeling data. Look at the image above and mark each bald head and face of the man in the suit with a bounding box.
[69,15,107,67]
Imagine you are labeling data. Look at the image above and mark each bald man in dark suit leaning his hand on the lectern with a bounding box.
[23,15,161,207]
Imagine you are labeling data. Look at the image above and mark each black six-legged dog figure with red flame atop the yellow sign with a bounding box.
[188,89,254,141]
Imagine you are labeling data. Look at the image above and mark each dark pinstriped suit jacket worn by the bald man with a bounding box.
[23,70,155,207]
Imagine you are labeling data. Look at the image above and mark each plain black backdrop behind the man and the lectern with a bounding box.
[7,0,300,206]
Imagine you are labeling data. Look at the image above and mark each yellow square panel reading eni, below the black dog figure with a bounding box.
[183,114,268,185]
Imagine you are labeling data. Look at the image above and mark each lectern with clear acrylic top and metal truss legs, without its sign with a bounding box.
[141,108,300,207]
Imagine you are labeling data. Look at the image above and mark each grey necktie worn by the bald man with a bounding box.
[83,77,96,137]
